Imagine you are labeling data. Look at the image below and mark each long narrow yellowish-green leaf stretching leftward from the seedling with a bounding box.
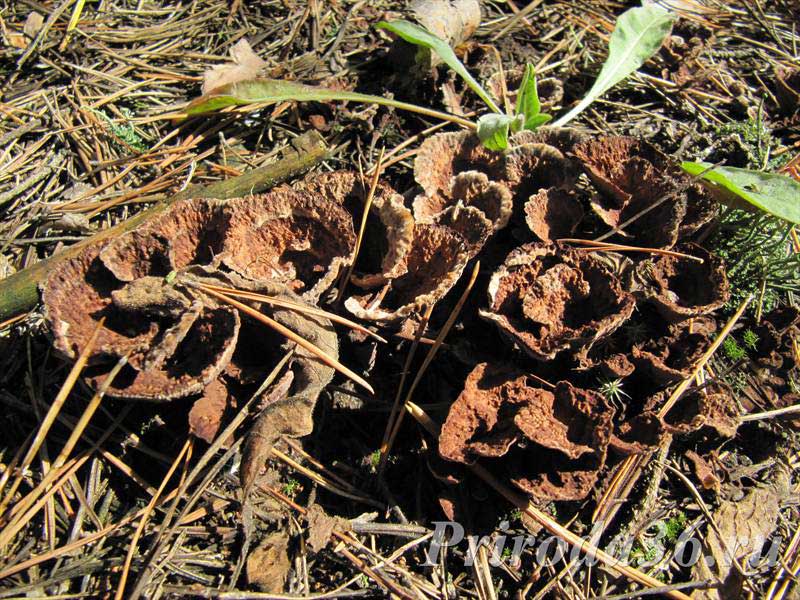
[184,79,475,129]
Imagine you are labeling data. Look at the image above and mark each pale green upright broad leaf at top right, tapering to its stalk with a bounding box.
[554,4,674,127]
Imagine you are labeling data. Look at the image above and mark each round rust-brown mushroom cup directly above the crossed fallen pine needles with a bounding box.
[222,188,355,302]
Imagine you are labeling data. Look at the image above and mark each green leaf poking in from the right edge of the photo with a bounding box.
[681,162,800,224]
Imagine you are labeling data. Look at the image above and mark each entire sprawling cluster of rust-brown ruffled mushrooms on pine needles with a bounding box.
[43,128,744,500]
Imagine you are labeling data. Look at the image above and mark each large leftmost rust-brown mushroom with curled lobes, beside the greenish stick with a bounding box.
[42,194,347,404]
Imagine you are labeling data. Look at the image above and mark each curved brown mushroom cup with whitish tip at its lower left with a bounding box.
[344,223,470,322]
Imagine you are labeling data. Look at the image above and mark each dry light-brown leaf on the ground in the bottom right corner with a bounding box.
[692,472,786,600]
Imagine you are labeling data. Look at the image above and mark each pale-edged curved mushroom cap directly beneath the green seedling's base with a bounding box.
[414,131,504,196]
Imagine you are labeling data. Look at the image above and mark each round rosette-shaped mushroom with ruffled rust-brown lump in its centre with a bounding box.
[480,244,634,360]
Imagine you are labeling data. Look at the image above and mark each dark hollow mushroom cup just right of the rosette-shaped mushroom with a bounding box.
[634,244,730,323]
